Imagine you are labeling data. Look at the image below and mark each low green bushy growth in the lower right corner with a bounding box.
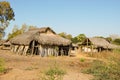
[83,60,120,80]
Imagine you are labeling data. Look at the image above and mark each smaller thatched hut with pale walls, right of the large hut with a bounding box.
[82,37,115,52]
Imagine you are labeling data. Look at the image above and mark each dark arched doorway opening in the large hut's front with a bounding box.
[29,40,39,55]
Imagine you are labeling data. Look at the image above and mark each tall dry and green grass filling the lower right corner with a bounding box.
[83,53,120,80]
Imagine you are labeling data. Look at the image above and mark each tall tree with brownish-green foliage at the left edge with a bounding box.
[0,1,15,39]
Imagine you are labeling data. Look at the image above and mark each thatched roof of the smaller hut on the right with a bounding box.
[83,37,115,48]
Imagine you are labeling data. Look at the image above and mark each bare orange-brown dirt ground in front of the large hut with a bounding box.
[0,50,93,80]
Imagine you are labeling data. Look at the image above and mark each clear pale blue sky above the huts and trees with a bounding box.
[1,0,120,37]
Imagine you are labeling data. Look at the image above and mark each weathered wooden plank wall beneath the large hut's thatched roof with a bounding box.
[11,44,69,57]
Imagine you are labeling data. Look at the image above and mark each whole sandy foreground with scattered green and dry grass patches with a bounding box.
[0,50,120,80]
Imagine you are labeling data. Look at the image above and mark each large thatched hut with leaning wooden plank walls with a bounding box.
[10,27,71,56]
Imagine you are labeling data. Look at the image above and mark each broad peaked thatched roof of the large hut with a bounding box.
[10,27,71,46]
